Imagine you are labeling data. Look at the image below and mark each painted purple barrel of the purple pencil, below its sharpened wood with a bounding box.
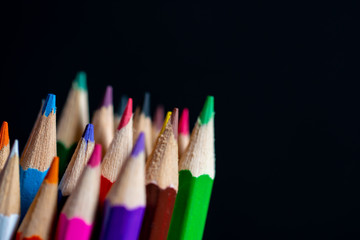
[100,202,145,240]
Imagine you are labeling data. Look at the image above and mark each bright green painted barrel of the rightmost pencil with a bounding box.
[167,170,214,240]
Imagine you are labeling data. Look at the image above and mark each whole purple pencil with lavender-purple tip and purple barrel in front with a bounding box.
[100,133,146,240]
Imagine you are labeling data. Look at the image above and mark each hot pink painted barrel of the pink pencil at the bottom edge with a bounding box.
[56,214,93,240]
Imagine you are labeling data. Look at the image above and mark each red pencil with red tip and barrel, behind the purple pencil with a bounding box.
[100,98,133,205]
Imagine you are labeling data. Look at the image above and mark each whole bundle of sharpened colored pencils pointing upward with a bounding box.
[0,72,215,240]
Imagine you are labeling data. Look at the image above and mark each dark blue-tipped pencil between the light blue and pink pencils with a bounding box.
[59,123,95,206]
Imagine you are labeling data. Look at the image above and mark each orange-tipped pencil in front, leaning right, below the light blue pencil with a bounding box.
[16,157,59,240]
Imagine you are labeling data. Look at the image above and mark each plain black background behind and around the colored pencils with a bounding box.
[0,0,360,239]
